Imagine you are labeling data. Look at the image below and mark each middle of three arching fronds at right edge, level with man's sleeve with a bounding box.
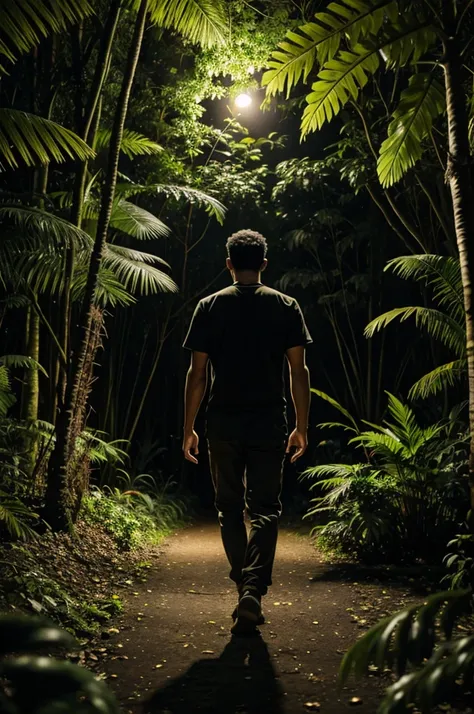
[364,306,466,357]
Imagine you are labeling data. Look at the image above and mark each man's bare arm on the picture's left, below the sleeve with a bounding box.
[183,352,209,464]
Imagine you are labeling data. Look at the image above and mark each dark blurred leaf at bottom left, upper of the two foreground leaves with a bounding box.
[0,615,77,655]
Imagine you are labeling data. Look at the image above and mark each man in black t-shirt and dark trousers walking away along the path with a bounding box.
[183,225,312,634]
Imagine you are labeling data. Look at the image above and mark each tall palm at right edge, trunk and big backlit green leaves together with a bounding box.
[263,0,474,509]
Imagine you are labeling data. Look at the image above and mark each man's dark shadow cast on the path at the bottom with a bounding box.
[144,636,283,714]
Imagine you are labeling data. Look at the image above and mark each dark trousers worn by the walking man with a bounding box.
[209,438,285,595]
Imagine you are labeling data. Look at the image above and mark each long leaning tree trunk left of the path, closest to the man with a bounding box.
[44,0,148,530]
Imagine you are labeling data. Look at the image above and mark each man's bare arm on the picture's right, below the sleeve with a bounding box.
[286,346,311,463]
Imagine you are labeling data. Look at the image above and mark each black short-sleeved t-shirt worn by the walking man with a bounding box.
[184,283,312,415]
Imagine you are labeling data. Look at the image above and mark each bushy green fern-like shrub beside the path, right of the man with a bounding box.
[303,390,468,562]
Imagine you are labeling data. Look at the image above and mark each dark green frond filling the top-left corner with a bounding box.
[0,0,92,73]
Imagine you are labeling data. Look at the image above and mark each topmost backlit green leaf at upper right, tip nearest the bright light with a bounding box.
[262,0,398,97]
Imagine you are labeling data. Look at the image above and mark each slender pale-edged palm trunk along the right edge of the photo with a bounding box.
[444,38,474,512]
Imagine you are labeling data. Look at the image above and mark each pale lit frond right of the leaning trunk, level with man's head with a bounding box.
[104,243,178,295]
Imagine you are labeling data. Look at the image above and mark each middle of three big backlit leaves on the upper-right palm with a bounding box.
[301,45,380,138]
